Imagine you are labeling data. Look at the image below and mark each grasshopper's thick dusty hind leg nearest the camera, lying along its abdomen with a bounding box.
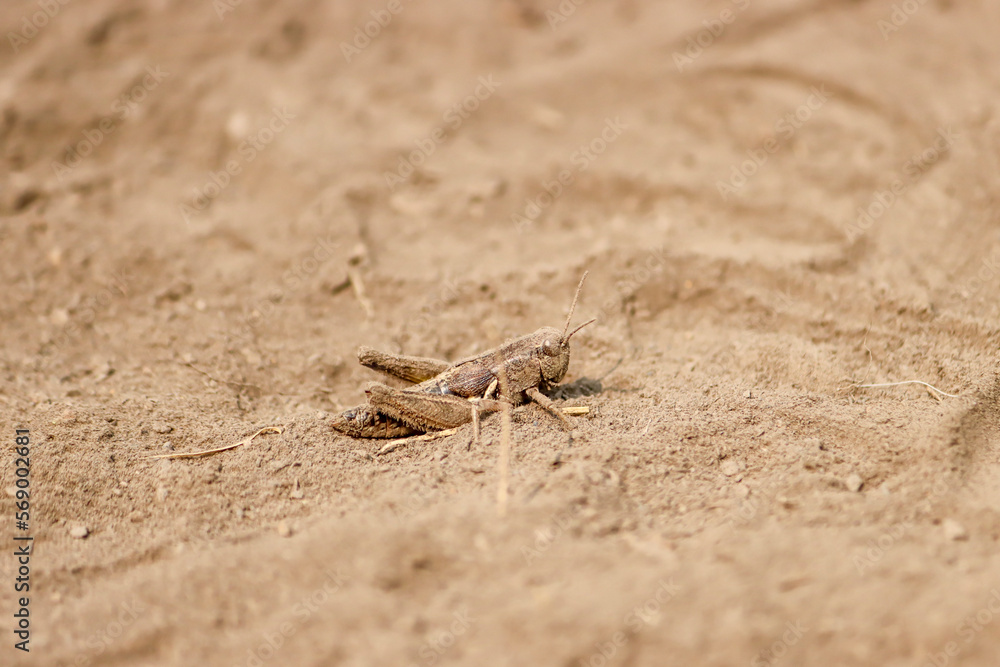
[365,382,501,431]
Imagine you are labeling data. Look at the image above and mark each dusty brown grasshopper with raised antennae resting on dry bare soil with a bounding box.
[332,272,595,438]
